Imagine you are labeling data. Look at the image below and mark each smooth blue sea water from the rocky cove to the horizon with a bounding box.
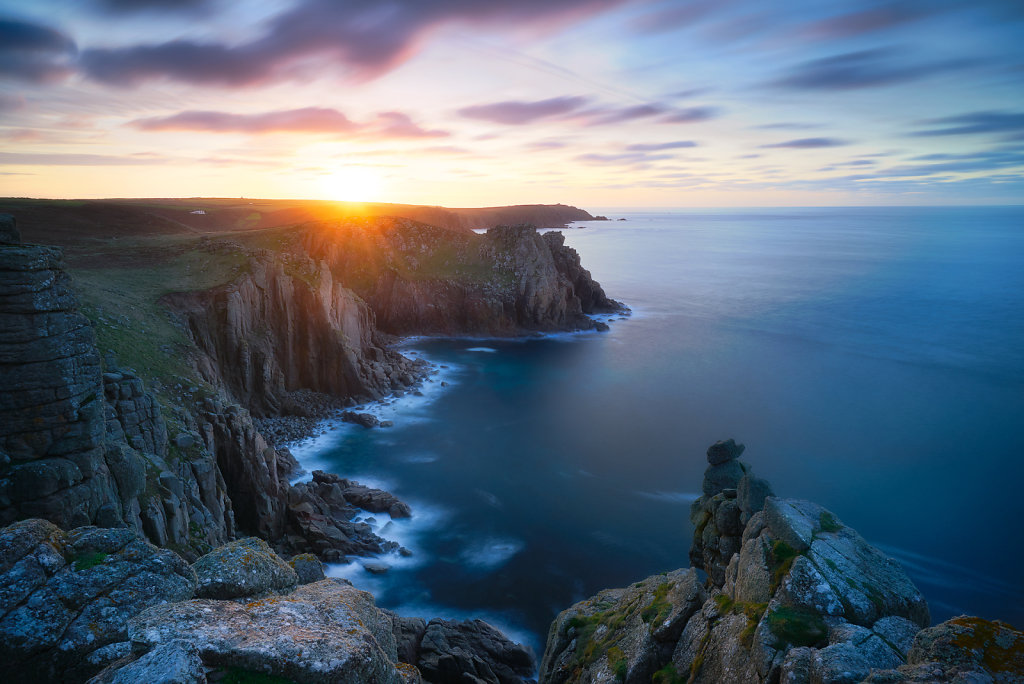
[299,208,1024,648]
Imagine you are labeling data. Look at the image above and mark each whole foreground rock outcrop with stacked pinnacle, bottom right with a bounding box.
[541,440,1024,684]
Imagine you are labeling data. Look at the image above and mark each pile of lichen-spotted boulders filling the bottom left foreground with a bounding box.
[0,520,535,684]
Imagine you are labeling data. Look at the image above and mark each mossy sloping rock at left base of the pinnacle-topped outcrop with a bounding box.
[541,569,707,684]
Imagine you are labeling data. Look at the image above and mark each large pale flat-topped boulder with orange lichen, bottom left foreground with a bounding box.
[128,580,409,684]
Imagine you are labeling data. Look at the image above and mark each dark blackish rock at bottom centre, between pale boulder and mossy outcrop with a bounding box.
[416,619,536,684]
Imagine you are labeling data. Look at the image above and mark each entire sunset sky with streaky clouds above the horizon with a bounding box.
[0,0,1024,208]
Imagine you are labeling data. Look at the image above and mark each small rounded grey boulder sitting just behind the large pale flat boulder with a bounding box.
[193,537,299,599]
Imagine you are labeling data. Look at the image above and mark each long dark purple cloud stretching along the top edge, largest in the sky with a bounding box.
[81,0,626,87]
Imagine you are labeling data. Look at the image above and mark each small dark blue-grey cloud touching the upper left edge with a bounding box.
[0,18,77,83]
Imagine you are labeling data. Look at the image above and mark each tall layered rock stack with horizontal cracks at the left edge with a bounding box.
[0,229,120,527]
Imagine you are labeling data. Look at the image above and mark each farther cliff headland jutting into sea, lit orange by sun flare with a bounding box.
[303,219,623,336]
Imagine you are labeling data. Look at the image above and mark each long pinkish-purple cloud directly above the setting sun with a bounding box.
[130,106,449,139]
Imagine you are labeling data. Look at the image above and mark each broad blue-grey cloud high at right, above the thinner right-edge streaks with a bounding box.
[771,49,974,90]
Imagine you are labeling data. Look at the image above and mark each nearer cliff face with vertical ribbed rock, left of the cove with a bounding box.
[164,245,416,417]
